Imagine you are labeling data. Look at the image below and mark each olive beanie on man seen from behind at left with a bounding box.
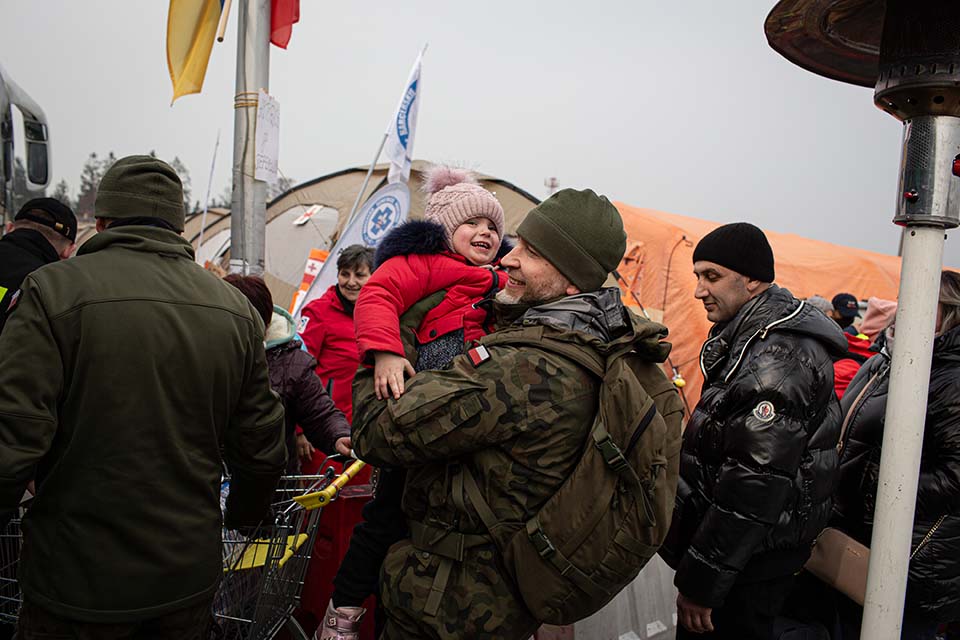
[94,156,185,231]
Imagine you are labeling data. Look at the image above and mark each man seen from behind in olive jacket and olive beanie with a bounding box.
[0,156,286,640]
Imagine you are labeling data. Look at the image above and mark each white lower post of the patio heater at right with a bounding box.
[860,226,943,640]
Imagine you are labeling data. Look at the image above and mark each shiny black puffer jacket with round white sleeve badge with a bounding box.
[664,285,847,608]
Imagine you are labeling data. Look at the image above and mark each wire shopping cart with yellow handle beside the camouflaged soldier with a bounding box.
[213,458,364,640]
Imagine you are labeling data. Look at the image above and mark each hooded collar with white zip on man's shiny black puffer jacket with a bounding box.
[700,285,847,382]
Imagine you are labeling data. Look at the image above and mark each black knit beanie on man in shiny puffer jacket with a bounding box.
[693,222,774,282]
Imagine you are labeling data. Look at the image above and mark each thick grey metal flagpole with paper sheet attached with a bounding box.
[230,0,270,275]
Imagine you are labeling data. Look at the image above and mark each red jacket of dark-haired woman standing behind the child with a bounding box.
[300,285,360,420]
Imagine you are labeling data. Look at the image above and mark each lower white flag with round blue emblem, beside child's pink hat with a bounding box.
[293,182,410,317]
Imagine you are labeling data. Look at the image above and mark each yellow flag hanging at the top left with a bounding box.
[167,0,223,104]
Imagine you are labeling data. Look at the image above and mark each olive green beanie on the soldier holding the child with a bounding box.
[517,189,627,291]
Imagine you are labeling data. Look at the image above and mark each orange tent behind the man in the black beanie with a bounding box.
[615,202,900,409]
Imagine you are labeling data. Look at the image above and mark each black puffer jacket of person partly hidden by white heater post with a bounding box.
[831,327,960,622]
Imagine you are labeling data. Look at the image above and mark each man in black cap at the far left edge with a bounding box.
[0,198,77,330]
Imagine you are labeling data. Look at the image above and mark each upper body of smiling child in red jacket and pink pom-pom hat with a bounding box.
[354,167,506,398]
